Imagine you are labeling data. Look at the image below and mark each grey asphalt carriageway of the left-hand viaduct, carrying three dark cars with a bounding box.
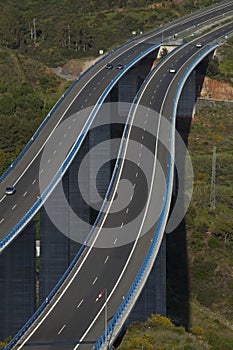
[0,2,233,251]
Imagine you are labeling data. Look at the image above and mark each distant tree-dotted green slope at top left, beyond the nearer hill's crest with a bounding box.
[0,0,222,66]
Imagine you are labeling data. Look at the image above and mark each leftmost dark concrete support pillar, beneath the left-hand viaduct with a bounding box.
[0,222,36,340]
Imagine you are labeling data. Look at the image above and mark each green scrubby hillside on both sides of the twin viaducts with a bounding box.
[0,0,233,350]
